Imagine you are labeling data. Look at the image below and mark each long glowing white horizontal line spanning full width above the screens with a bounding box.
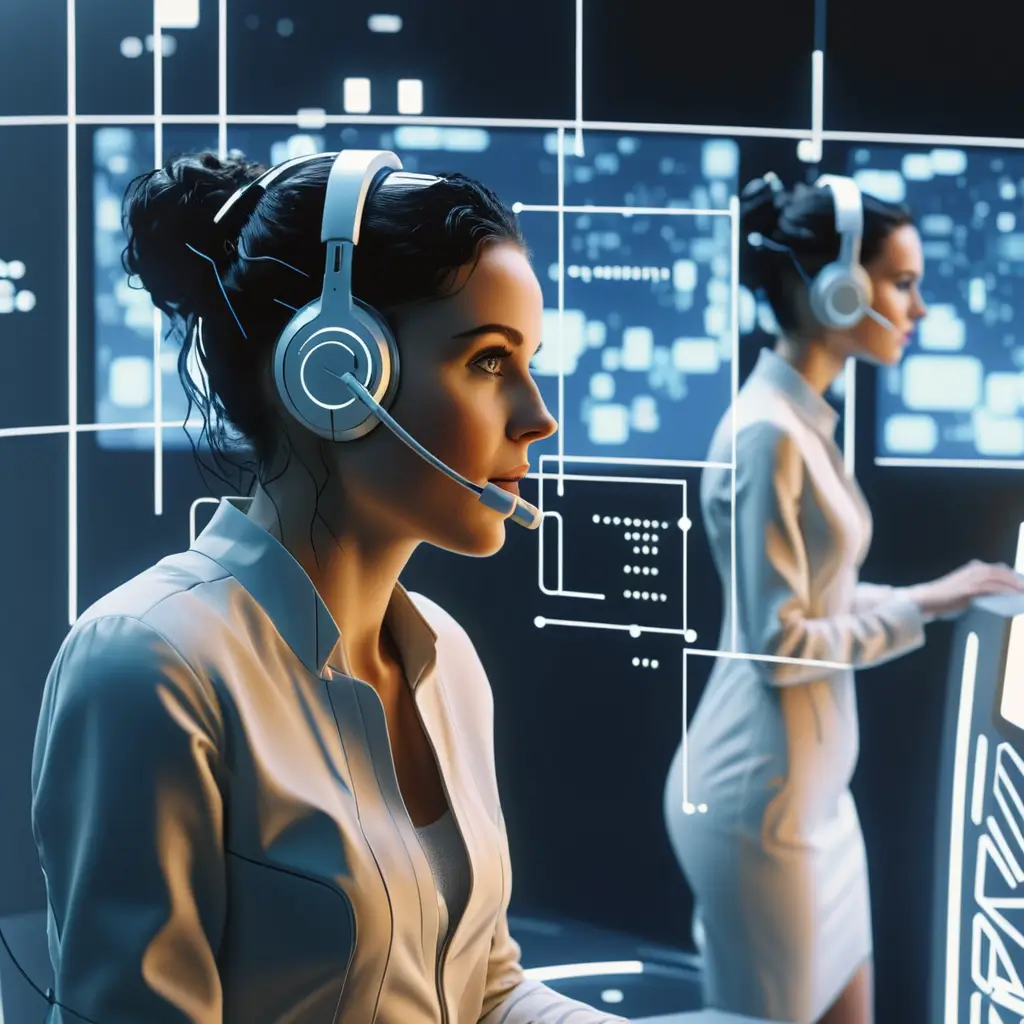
[6,112,1024,150]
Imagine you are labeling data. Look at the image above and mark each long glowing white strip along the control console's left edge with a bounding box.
[943,633,978,1024]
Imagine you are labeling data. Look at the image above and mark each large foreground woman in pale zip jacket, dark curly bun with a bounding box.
[33,154,620,1024]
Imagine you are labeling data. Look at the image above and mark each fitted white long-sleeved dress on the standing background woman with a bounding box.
[665,350,924,1024]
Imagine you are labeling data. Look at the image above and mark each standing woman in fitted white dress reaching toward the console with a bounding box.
[665,175,1019,1024]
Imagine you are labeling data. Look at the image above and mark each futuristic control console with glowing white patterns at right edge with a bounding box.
[930,594,1024,1024]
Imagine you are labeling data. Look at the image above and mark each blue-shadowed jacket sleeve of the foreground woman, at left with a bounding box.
[32,616,225,1024]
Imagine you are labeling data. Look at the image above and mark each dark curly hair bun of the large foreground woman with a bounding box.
[122,153,263,318]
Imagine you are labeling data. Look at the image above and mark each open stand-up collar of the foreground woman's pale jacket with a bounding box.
[193,498,437,687]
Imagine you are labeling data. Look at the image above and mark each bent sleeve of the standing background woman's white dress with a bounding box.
[712,422,925,686]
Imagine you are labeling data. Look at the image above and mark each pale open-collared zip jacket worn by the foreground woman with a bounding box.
[32,501,621,1024]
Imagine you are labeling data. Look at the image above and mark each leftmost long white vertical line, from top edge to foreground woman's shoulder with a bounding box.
[68,0,78,626]
